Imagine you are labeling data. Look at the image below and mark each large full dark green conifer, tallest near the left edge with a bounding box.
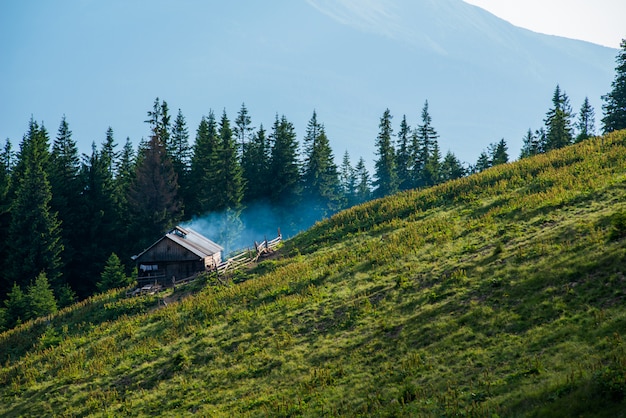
[6,126,63,288]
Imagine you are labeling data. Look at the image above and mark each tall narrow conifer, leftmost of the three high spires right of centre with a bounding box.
[374,109,398,197]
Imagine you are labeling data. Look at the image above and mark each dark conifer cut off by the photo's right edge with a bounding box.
[602,39,626,133]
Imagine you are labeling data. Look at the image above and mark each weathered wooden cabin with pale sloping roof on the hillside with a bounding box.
[134,226,224,286]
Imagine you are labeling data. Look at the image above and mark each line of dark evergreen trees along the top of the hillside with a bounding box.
[0,40,626,329]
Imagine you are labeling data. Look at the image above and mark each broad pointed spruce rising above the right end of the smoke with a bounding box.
[302,111,340,220]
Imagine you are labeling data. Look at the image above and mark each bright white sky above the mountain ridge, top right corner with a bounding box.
[464,0,626,48]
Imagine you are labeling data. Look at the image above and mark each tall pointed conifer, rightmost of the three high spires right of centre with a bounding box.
[411,100,439,187]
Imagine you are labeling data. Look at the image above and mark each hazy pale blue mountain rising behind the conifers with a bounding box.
[0,0,617,164]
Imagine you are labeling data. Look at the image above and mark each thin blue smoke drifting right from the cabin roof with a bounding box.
[182,198,323,257]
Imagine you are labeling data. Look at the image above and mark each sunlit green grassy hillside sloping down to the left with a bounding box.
[0,132,626,417]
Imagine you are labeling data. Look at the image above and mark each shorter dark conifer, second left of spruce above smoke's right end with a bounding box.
[241,125,270,203]
